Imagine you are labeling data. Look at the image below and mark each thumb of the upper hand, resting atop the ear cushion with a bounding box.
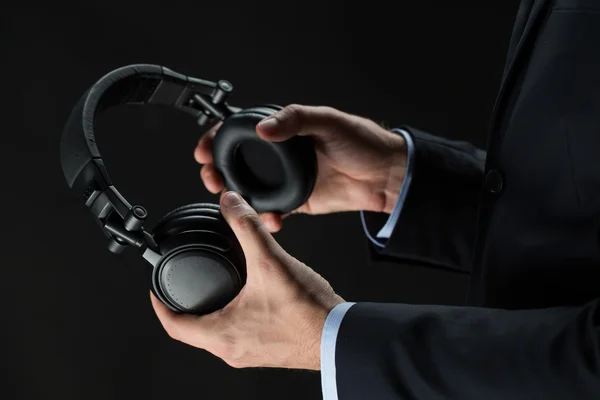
[256,104,345,142]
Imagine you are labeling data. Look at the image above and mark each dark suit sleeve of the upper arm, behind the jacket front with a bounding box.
[363,126,486,272]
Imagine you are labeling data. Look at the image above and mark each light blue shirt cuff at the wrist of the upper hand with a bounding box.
[360,129,415,247]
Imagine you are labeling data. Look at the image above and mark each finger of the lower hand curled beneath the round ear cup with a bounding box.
[150,292,217,349]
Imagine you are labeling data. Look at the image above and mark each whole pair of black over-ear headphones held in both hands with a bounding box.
[60,64,317,315]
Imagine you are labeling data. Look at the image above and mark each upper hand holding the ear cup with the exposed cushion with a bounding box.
[194,104,407,232]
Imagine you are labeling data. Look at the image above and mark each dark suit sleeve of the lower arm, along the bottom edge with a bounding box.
[332,300,600,400]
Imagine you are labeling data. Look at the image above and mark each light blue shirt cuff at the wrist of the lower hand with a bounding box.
[321,303,356,400]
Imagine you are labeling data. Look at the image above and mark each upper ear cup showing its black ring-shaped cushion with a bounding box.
[212,105,317,214]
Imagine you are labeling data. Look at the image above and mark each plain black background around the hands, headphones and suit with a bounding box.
[0,0,518,399]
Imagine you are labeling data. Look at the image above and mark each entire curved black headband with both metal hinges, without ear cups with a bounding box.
[60,64,239,252]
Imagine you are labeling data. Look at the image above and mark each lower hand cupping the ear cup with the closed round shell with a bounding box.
[151,192,344,370]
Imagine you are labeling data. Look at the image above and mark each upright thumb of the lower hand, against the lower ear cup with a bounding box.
[221,192,283,258]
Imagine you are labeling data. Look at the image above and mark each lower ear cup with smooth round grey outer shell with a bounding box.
[151,203,246,315]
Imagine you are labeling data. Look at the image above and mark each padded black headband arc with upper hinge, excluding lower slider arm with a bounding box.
[60,64,233,197]
